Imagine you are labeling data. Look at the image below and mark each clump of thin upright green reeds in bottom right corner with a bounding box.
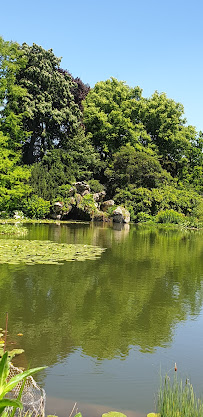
[158,375,203,417]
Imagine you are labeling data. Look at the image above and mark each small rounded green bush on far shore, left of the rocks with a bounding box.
[23,195,50,219]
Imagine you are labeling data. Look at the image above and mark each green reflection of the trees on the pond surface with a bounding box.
[0,224,203,412]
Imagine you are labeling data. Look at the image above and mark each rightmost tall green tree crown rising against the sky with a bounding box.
[139,91,196,176]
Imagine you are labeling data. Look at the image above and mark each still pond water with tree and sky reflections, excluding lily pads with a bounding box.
[0,223,203,417]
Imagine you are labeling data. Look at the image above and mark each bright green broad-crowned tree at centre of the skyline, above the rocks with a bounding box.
[83,78,150,159]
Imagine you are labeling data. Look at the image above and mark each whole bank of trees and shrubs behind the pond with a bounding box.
[0,38,203,225]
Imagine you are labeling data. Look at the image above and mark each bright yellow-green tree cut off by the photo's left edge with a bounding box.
[0,37,31,212]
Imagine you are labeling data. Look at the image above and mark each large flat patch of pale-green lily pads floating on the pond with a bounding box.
[0,239,105,265]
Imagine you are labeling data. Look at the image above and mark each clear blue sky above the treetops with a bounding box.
[0,0,203,131]
